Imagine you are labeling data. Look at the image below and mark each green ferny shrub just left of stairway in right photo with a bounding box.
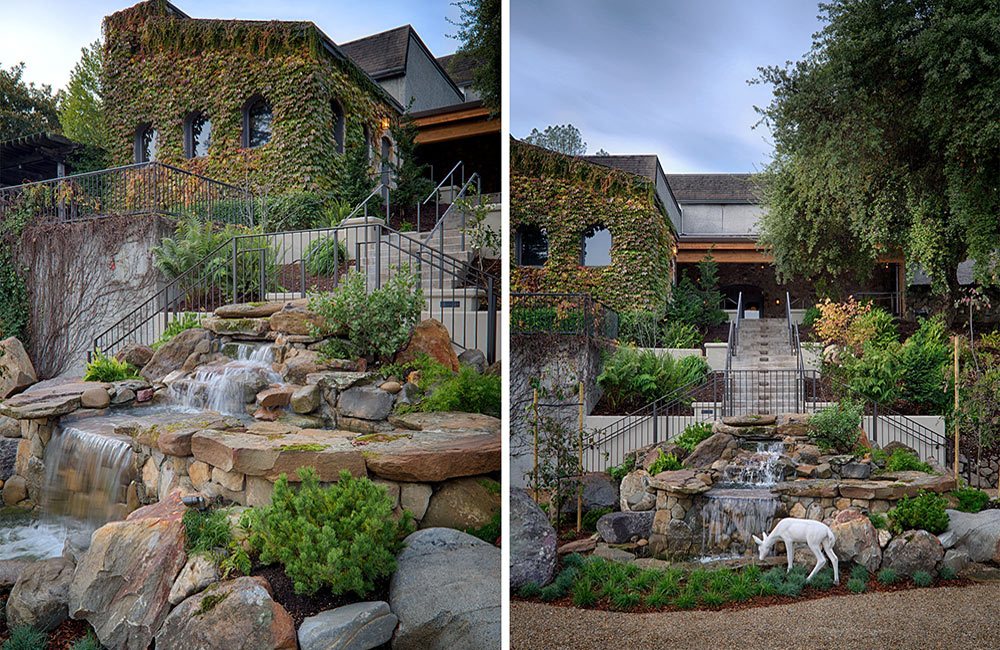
[597,346,709,412]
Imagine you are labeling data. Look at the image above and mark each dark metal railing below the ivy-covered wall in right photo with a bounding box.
[510,293,618,339]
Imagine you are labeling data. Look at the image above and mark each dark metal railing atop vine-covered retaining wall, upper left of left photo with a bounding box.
[0,162,254,226]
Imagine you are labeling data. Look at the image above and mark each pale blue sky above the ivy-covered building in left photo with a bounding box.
[0,0,459,89]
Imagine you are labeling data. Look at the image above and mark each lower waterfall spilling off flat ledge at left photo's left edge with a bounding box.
[42,426,135,526]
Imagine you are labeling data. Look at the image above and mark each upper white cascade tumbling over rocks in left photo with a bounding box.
[170,344,281,416]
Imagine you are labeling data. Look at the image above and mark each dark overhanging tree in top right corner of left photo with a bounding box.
[453,0,502,115]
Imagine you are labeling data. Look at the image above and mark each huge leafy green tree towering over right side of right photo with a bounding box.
[755,0,1000,304]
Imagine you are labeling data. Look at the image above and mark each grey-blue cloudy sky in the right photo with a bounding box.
[510,0,820,173]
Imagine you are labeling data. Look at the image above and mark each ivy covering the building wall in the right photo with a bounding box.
[510,140,675,311]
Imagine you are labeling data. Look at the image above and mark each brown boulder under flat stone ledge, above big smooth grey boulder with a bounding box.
[420,477,500,530]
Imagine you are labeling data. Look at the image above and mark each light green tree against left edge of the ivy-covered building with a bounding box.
[58,41,107,171]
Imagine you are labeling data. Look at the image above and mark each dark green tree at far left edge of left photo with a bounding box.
[0,63,59,142]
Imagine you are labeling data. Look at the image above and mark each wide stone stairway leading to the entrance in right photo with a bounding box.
[727,318,800,413]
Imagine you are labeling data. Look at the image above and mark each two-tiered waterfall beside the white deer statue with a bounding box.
[701,442,785,556]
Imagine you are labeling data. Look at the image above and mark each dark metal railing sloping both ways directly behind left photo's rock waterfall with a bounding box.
[94,188,499,363]
